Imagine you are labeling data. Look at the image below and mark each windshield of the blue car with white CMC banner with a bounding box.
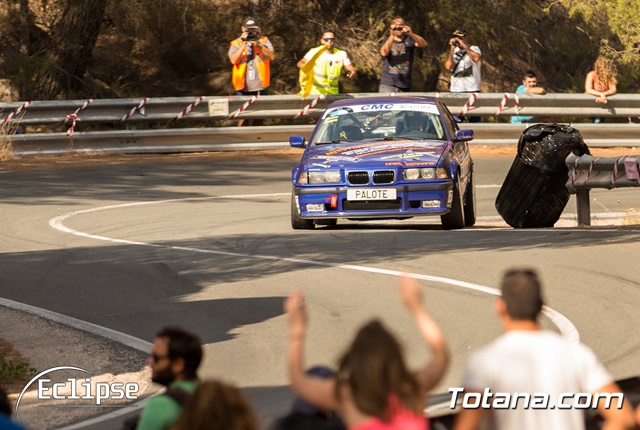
[311,103,447,145]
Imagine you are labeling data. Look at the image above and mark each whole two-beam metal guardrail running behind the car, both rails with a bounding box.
[0,93,640,155]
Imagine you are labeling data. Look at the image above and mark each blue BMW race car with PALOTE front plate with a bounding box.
[289,96,476,230]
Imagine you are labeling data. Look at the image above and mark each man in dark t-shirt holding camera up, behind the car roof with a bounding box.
[378,16,427,93]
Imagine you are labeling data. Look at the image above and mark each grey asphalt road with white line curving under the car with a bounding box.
[0,157,640,426]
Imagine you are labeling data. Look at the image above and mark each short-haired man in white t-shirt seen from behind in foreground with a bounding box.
[454,270,633,430]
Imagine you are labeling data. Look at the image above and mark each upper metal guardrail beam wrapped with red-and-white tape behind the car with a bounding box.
[0,93,640,125]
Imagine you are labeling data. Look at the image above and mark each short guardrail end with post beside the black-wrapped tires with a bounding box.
[565,154,640,225]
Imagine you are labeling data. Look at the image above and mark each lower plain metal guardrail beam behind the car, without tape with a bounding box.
[5,123,640,155]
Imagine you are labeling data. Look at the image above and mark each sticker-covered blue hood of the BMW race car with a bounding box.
[304,140,448,168]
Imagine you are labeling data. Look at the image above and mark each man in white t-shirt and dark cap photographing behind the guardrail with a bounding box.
[444,28,482,122]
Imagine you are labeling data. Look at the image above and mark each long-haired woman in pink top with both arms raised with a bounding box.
[285,276,449,429]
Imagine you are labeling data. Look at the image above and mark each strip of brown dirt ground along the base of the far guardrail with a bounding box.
[0,145,640,172]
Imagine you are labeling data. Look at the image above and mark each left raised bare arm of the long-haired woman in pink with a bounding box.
[284,291,338,411]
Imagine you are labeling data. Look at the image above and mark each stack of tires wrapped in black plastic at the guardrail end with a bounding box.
[496,124,589,228]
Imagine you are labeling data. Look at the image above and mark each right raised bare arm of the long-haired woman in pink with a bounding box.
[398,275,449,393]
